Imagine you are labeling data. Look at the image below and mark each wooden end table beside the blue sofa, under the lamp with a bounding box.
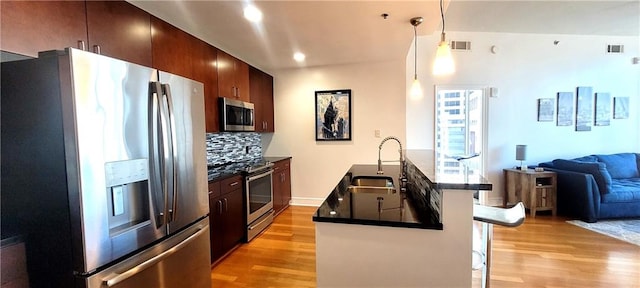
[503,169,557,218]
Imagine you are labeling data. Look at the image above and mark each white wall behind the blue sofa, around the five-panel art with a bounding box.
[405,32,640,203]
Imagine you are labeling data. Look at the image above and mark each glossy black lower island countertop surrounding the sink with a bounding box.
[313,165,442,230]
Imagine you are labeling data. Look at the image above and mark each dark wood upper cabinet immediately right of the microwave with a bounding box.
[249,67,275,132]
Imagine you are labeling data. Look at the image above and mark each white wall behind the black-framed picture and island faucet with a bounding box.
[262,61,406,205]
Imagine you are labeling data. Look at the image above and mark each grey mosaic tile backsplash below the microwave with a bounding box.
[207,132,262,166]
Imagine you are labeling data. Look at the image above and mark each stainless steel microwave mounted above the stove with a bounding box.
[219,97,256,131]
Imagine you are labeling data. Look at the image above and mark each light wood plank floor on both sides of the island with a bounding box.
[211,206,640,288]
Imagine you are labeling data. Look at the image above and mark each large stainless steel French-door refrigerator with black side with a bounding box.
[0,48,210,287]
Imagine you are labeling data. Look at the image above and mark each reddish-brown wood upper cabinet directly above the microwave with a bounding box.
[218,51,250,102]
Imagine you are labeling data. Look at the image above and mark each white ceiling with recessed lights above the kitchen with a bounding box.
[129,0,640,71]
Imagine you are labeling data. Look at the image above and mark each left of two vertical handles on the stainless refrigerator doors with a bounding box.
[149,82,168,228]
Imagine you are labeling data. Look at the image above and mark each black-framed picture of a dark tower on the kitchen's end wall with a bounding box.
[315,89,352,141]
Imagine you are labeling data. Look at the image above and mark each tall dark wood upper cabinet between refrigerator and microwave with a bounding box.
[192,37,220,133]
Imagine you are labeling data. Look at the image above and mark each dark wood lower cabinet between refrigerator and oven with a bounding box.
[209,174,246,264]
